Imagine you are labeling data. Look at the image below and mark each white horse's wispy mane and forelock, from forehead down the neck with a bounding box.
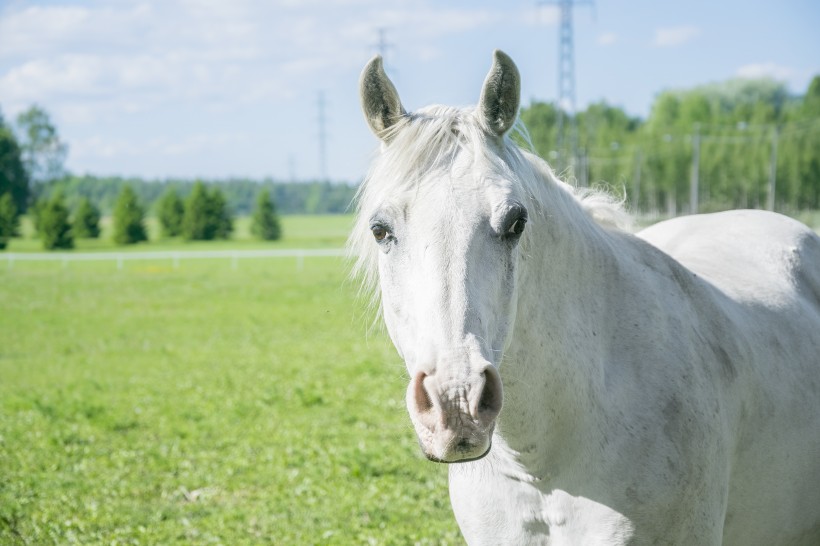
[347,105,632,307]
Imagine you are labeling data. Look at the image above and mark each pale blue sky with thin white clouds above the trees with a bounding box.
[0,0,820,182]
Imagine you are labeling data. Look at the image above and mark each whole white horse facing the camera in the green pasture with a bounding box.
[350,51,820,545]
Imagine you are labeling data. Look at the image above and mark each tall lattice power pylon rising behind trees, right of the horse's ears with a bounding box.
[541,0,593,176]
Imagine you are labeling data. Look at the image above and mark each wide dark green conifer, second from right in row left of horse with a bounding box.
[182,181,233,241]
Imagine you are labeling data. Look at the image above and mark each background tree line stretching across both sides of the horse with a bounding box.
[0,76,820,246]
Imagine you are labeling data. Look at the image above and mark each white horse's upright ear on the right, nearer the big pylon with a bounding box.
[478,49,521,136]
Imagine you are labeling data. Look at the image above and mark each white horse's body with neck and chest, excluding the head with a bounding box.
[450,203,820,545]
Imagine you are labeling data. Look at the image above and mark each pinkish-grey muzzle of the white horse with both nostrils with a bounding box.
[407,364,503,463]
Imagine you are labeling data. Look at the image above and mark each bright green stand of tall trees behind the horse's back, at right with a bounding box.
[521,76,820,216]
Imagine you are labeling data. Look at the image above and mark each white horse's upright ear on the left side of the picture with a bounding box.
[359,55,407,142]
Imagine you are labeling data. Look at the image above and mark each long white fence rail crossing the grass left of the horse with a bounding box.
[0,248,345,271]
